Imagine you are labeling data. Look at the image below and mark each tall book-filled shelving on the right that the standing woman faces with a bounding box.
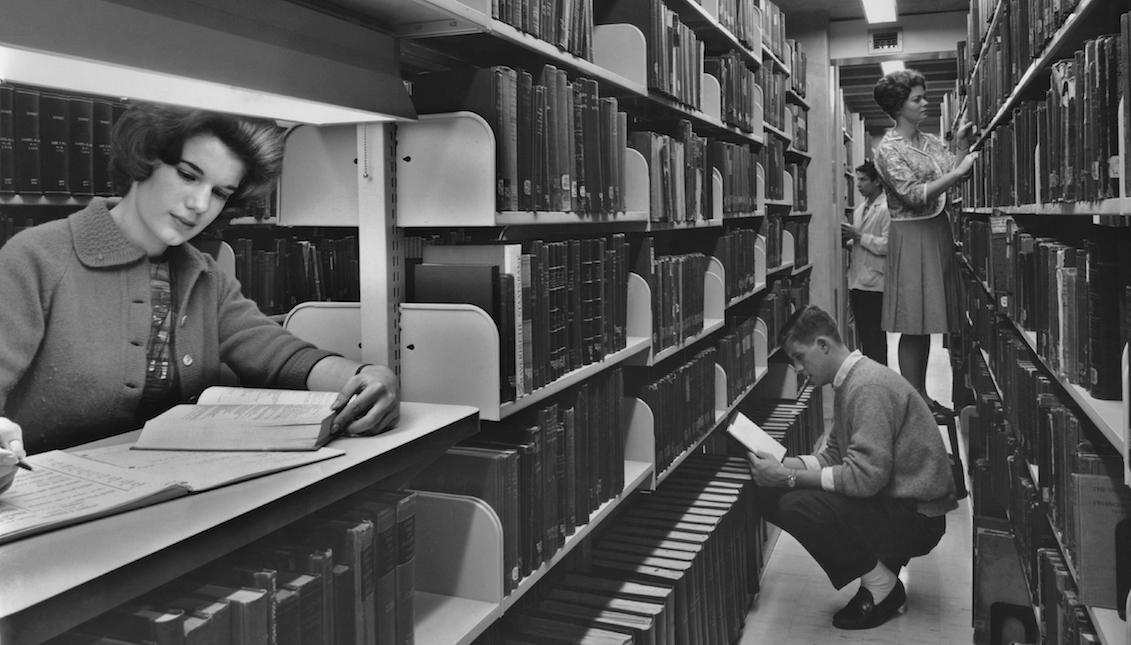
[957,0,1131,645]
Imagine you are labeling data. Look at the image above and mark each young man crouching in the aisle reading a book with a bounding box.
[746,306,958,629]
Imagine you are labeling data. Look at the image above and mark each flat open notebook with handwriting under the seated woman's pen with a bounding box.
[0,444,345,543]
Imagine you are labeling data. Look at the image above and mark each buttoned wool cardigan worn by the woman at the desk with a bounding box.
[0,199,331,453]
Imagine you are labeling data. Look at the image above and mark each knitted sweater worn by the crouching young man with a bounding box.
[817,358,958,517]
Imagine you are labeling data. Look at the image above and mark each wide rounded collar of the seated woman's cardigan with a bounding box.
[69,198,204,269]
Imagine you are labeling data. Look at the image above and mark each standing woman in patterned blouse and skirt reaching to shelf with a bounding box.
[872,69,977,422]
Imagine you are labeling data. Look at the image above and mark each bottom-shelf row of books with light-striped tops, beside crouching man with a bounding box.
[477,455,762,645]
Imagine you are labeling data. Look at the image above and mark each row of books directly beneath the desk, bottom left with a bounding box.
[49,488,416,645]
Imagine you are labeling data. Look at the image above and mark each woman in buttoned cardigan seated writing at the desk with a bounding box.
[0,103,399,490]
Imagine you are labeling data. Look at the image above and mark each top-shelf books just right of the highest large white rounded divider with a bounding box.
[594,0,703,110]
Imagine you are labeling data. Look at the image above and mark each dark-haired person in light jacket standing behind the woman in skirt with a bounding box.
[840,161,891,366]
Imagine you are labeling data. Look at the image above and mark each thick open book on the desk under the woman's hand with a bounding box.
[133,386,338,452]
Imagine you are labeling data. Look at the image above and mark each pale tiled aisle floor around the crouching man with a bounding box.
[739,334,974,645]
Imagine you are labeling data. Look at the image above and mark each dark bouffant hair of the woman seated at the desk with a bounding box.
[110,102,284,207]
